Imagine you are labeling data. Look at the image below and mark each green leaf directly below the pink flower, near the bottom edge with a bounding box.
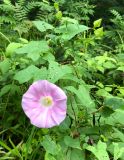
[41,135,61,155]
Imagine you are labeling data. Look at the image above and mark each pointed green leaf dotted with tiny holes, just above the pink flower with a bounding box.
[48,61,72,83]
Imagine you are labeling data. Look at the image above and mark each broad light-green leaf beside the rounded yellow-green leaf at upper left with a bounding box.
[16,41,49,61]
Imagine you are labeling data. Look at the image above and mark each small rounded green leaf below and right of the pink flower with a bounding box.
[64,136,81,149]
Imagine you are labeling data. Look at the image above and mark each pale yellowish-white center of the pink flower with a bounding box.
[40,96,53,107]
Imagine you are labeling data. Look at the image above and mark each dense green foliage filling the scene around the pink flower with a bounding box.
[0,0,124,160]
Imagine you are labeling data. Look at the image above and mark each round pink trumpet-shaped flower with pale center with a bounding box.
[22,80,67,128]
